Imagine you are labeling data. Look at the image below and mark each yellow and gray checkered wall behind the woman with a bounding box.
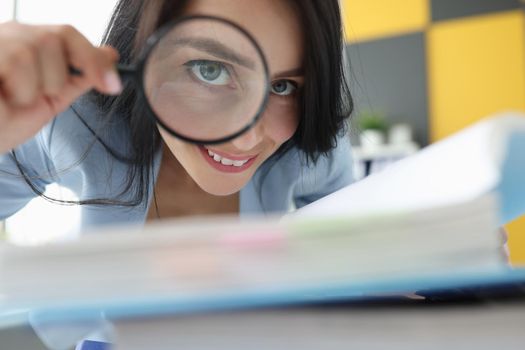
[342,0,525,265]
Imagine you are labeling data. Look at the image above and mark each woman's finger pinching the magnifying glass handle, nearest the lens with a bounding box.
[53,26,121,94]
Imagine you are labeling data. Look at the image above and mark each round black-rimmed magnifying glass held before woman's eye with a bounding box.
[74,16,270,145]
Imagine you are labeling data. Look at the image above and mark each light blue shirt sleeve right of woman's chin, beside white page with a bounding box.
[294,135,354,209]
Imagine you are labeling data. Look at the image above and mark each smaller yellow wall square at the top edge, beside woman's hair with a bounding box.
[341,0,429,42]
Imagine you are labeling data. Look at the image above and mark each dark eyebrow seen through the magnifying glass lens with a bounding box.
[173,37,256,70]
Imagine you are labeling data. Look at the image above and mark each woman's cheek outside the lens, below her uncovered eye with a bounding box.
[263,99,299,144]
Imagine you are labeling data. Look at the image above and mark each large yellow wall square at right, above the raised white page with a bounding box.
[427,10,525,141]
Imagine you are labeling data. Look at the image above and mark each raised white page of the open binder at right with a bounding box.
[294,113,525,217]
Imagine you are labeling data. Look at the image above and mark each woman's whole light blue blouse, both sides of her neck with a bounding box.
[0,98,352,230]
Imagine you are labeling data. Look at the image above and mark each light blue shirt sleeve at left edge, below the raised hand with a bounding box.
[0,133,53,220]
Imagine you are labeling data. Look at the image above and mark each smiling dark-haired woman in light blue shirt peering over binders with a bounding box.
[0,0,352,229]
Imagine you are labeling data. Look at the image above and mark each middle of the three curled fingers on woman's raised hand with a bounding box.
[38,32,69,96]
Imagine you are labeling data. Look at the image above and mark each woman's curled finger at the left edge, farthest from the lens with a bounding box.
[0,44,41,106]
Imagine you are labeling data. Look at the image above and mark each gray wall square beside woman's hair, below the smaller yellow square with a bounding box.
[346,32,429,145]
